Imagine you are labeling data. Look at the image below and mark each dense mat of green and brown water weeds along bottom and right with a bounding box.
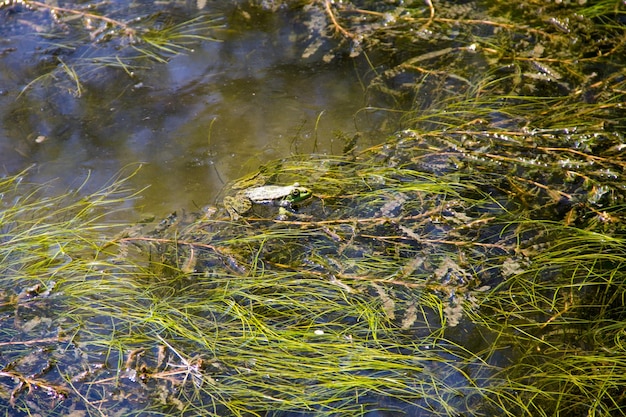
[0,1,626,417]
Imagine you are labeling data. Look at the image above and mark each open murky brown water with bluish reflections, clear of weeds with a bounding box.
[0,4,368,214]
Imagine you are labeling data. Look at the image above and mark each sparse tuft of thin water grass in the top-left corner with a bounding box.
[0,0,223,97]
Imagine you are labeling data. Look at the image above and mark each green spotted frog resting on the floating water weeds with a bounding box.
[224,182,313,220]
